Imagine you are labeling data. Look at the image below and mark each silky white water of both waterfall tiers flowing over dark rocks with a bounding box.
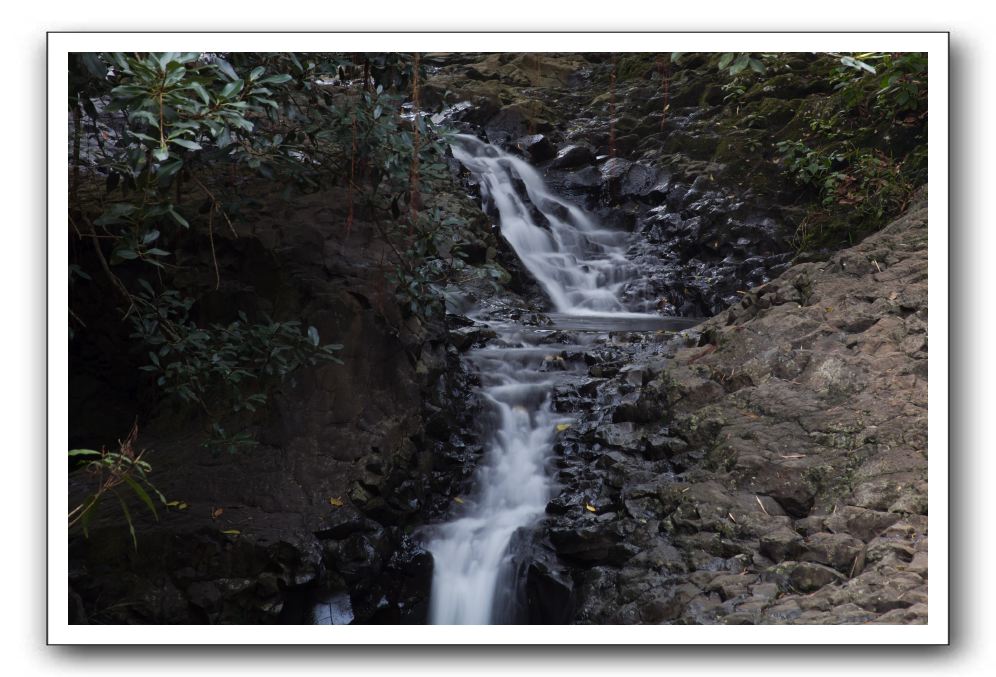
[427,135,651,624]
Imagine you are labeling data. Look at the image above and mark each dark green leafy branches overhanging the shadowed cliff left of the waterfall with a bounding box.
[68,52,472,540]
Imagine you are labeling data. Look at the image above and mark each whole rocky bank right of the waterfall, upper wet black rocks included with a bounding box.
[426,55,927,623]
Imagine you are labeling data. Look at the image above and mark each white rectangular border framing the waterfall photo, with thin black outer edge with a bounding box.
[47,32,950,645]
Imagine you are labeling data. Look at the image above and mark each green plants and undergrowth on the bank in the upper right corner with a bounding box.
[670,52,927,250]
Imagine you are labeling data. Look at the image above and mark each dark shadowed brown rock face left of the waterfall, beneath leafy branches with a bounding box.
[69,181,495,623]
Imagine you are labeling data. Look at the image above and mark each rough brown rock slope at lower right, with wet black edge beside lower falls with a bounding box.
[544,193,928,623]
